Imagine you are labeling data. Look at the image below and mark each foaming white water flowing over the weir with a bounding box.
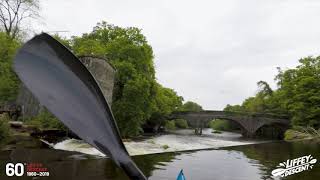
[53,129,266,156]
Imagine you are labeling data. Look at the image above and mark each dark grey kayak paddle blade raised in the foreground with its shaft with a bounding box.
[14,33,147,180]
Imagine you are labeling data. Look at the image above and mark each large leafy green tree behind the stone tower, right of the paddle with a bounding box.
[62,22,183,137]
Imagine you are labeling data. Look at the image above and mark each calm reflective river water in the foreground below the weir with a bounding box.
[0,141,320,180]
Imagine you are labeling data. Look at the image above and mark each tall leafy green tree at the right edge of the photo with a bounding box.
[276,56,320,128]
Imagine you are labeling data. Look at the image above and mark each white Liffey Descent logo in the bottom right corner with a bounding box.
[271,155,317,177]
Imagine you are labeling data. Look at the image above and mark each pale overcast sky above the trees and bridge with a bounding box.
[34,0,320,110]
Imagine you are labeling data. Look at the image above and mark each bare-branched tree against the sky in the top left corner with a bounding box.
[0,0,39,39]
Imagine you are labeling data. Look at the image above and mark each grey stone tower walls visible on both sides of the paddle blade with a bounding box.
[16,57,115,117]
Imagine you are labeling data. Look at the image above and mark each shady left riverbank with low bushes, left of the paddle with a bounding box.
[0,109,78,150]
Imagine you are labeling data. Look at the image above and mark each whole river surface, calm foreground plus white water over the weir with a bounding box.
[0,130,320,180]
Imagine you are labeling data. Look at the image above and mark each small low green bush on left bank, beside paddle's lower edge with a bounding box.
[26,109,67,130]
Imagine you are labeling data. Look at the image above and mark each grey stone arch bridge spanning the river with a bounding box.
[169,111,290,137]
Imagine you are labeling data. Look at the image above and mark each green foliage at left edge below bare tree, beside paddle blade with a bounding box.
[0,32,20,104]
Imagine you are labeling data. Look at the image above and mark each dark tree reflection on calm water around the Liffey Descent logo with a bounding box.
[224,141,320,180]
